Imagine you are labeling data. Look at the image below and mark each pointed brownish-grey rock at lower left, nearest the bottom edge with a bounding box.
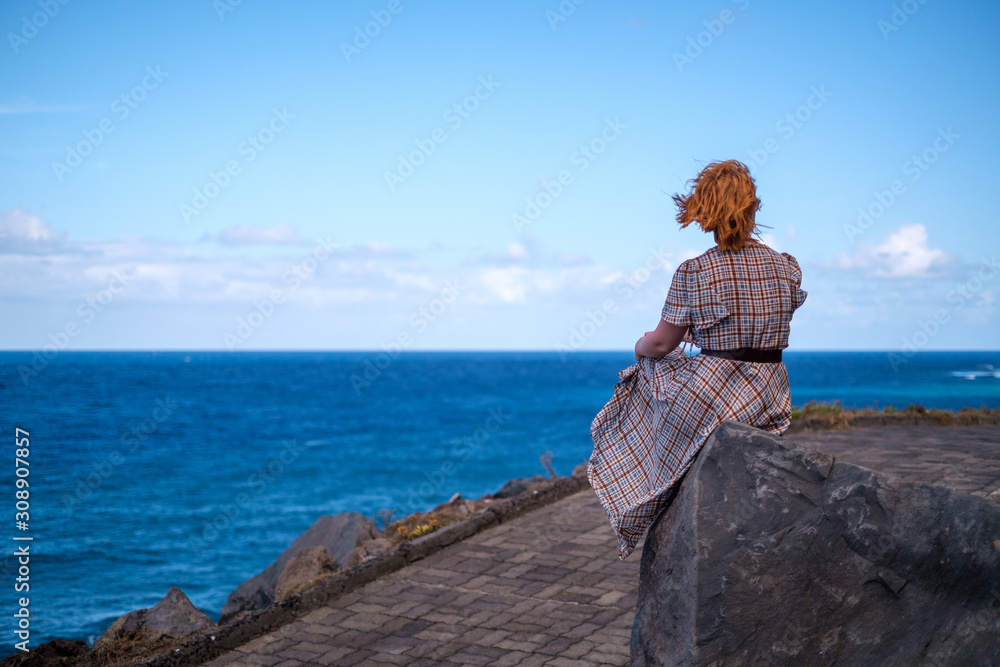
[93,586,217,664]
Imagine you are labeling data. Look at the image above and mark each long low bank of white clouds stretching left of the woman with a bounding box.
[0,210,690,310]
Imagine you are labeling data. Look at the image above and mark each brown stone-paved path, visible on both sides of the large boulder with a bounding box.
[206,427,1000,667]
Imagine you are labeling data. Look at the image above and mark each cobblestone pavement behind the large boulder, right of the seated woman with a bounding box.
[785,426,1000,496]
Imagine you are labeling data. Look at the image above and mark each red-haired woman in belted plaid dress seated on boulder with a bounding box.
[587,160,806,560]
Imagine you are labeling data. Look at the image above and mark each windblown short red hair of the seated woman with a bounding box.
[672,160,760,250]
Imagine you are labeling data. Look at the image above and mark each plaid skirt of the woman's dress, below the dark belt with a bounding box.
[587,347,792,560]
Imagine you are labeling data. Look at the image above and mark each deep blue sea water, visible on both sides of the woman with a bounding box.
[0,351,1000,655]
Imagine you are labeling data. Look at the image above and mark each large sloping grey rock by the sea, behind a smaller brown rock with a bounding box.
[219,512,377,624]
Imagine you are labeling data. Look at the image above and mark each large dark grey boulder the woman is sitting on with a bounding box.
[630,422,1000,665]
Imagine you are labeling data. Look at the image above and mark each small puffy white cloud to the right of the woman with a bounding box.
[835,224,954,278]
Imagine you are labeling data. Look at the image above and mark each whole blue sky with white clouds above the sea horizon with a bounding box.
[0,0,1000,350]
